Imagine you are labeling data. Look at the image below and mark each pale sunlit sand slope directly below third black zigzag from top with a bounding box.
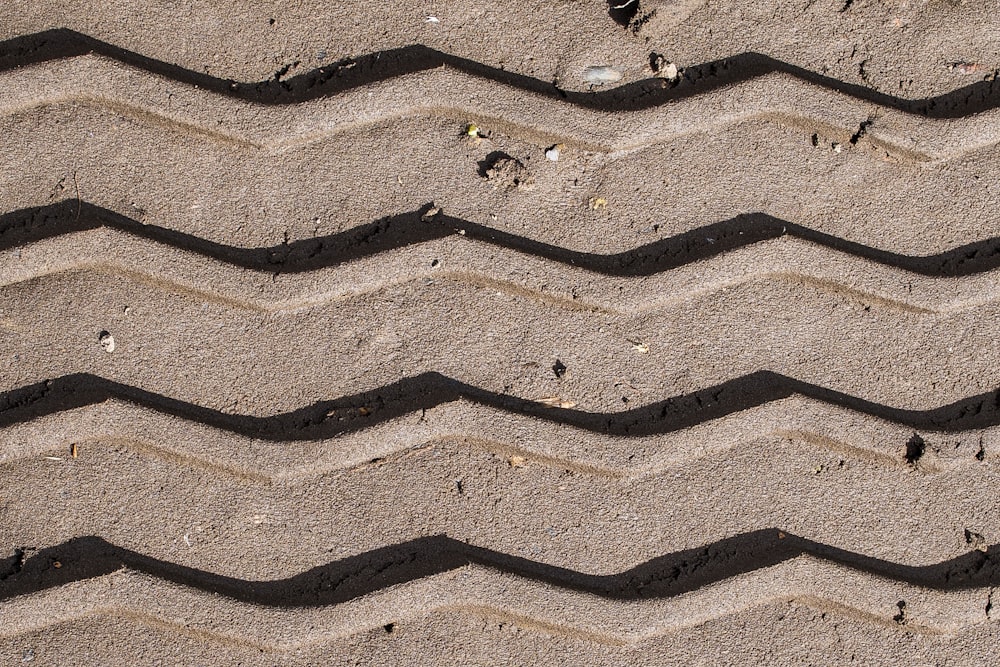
[0,397,976,483]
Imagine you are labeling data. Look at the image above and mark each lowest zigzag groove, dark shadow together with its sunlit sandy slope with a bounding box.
[0,530,997,644]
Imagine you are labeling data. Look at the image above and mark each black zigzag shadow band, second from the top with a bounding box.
[0,199,1000,278]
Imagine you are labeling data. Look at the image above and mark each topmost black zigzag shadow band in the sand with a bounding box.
[0,28,1000,118]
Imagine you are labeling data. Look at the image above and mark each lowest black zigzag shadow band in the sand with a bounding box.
[0,529,1000,607]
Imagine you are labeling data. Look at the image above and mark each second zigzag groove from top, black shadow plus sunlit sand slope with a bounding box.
[0,204,1000,315]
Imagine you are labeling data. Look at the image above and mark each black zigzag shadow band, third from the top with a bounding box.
[0,371,1000,442]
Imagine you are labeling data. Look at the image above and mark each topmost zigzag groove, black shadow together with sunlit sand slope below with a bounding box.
[0,33,1000,160]
